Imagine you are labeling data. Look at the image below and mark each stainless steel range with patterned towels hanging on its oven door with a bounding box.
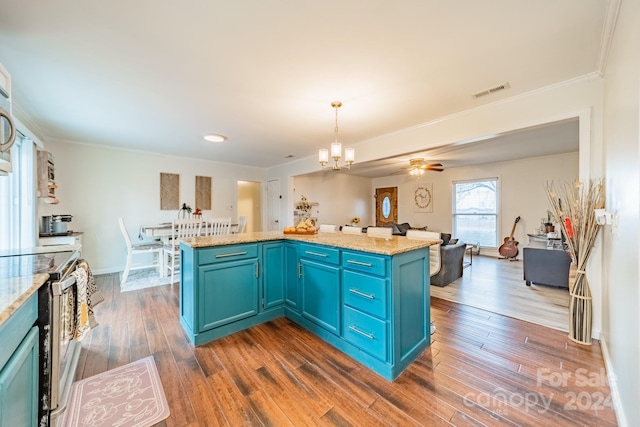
[0,249,81,426]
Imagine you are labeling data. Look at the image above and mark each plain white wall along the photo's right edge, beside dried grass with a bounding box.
[602,1,640,426]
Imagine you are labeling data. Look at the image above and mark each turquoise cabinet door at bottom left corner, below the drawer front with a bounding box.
[0,326,39,427]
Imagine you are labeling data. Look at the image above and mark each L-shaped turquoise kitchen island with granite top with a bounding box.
[180,232,437,380]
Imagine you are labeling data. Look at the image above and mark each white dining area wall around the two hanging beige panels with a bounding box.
[38,141,265,274]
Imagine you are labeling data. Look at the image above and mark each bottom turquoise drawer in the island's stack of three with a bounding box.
[342,306,388,361]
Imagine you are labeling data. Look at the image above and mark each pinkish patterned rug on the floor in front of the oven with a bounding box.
[58,356,169,427]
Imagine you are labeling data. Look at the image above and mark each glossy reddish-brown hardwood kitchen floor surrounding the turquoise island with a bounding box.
[76,274,616,426]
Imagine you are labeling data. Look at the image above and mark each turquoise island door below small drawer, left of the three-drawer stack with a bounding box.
[300,259,341,335]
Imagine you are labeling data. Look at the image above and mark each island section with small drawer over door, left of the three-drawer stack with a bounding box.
[300,244,341,335]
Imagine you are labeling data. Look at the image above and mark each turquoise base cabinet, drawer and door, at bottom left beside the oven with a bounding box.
[0,295,39,427]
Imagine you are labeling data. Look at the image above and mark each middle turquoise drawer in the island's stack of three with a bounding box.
[342,270,387,319]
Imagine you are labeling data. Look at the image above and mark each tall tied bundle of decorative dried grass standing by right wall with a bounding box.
[546,180,605,345]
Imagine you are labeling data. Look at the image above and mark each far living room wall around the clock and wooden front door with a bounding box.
[372,153,578,247]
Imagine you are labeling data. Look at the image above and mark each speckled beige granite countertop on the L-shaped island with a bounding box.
[183,231,440,255]
